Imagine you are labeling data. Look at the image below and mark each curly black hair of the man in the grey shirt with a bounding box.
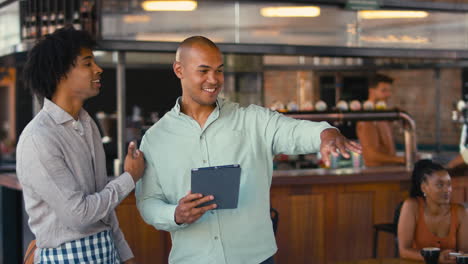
[23,26,96,102]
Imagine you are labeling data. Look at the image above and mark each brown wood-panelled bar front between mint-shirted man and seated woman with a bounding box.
[271,182,406,264]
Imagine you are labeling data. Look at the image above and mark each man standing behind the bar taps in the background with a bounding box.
[356,74,405,167]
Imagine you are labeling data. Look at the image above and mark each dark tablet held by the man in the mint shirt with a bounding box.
[191,164,241,209]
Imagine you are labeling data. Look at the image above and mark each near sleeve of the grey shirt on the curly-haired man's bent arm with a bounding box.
[19,134,135,230]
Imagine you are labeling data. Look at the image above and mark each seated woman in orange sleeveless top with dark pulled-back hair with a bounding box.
[398,160,468,263]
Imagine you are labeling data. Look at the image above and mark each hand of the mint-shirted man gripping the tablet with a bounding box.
[174,191,216,225]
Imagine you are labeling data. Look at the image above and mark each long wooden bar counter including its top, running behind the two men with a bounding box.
[0,167,468,264]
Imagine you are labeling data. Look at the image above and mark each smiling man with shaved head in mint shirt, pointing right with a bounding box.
[136,36,360,264]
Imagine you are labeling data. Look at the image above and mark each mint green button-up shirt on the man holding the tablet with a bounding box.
[136,99,331,264]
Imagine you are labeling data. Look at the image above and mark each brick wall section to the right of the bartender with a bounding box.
[381,69,461,145]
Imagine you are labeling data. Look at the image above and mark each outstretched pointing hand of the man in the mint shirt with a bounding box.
[320,128,362,166]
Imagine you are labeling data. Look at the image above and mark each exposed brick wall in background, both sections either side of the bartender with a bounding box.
[264,69,461,145]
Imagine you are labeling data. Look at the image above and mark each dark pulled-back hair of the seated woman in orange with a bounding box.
[410,159,446,198]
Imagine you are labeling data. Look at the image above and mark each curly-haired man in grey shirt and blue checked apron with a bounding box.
[17,27,145,264]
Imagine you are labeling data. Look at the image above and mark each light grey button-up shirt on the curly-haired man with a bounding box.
[16,99,135,261]
